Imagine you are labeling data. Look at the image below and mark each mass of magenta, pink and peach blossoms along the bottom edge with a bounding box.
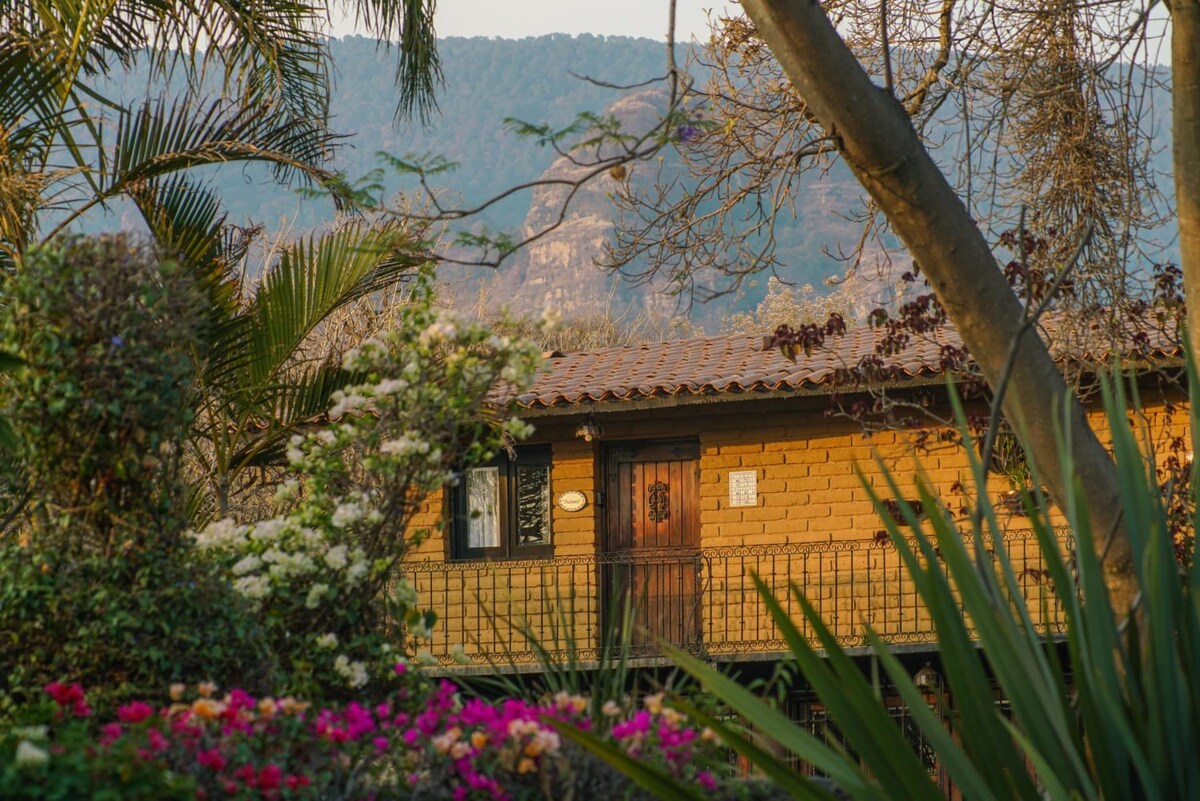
[30,670,719,801]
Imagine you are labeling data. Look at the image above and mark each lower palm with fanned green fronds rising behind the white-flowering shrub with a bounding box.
[184,219,422,524]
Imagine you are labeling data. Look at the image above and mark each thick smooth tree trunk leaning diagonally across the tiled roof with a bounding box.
[742,0,1142,615]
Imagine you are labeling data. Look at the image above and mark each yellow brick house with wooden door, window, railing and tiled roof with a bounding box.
[407,330,1187,669]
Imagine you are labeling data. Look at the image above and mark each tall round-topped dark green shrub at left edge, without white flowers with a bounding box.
[0,236,270,713]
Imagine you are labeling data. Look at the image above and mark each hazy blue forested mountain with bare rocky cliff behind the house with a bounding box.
[88,35,1176,327]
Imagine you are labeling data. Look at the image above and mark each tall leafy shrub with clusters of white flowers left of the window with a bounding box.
[196,278,540,697]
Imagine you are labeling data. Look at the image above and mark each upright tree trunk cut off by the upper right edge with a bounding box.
[1170,0,1200,355]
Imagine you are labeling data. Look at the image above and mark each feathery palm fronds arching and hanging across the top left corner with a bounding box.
[0,0,440,258]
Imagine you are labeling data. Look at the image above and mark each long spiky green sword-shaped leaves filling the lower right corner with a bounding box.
[570,383,1200,801]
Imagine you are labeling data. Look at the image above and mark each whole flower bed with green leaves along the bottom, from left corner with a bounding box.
[0,662,770,801]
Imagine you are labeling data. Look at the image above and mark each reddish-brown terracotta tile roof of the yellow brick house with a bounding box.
[517,323,1178,409]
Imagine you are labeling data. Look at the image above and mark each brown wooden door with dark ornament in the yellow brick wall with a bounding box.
[602,441,702,652]
